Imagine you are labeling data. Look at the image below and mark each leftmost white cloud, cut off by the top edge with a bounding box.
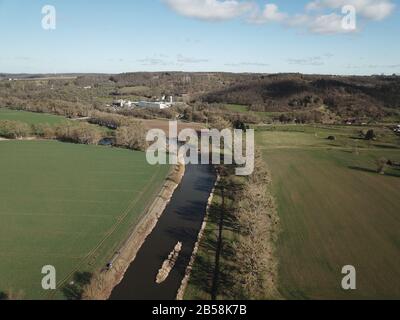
[163,0,254,20]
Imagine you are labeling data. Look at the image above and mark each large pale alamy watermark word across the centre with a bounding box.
[146,121,255,176]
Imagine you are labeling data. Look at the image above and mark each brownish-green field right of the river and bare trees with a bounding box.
[257,126,400,299]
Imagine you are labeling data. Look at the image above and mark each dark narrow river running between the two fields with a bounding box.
[110,165,216,300]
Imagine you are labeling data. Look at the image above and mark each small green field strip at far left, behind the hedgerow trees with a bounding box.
[0,108,68,125]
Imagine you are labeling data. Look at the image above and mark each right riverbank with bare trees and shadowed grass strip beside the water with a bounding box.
[184,159,280,300]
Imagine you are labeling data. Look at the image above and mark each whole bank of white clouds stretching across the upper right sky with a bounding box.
[162,0,395,34]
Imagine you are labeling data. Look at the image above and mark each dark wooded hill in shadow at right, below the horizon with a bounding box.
[201,75,400,116]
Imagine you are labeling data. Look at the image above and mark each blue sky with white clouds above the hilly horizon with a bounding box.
[0,0,400,74]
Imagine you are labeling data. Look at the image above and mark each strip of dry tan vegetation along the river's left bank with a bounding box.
[83,165,185,300]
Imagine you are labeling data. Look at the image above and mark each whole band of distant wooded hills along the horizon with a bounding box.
[0,72,400,118]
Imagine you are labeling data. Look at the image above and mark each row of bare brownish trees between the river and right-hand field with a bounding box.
[222,154,279,299]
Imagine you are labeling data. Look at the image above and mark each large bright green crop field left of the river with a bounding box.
[0,141,169,299]
